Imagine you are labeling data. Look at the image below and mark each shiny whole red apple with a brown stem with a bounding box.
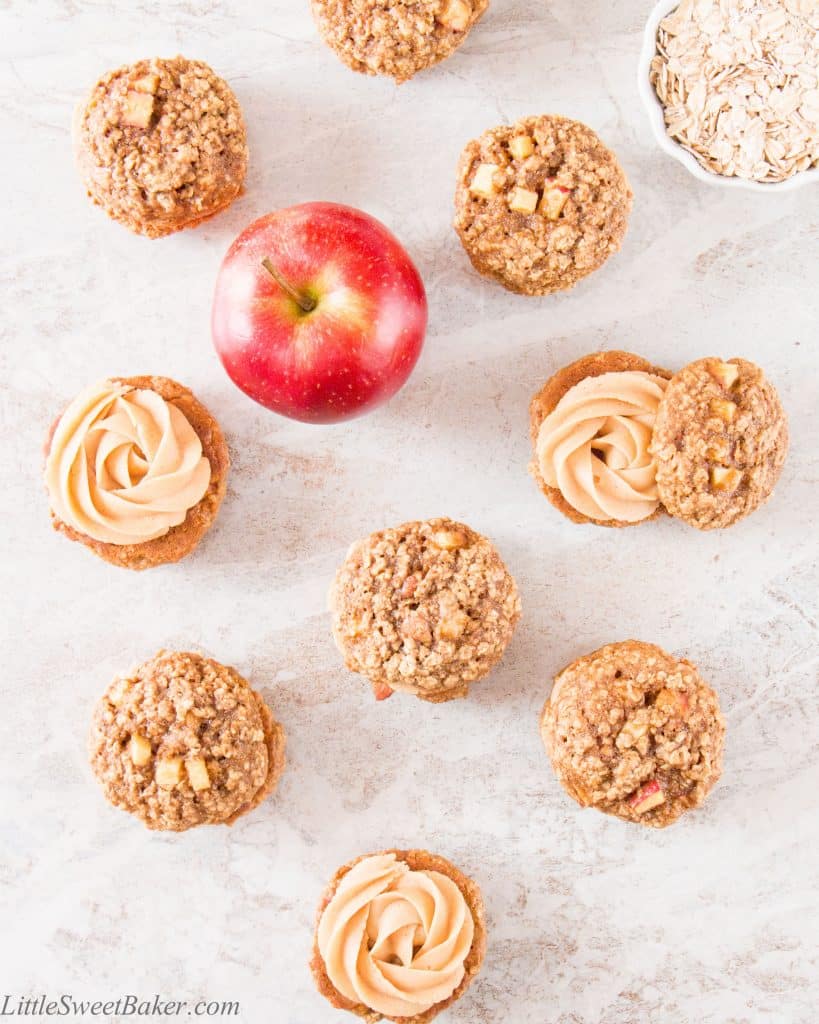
[212,203,427,423]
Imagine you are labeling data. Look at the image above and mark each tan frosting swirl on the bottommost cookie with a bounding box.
[317,853,475,1017]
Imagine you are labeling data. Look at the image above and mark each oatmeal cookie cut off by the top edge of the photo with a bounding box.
[310,0,489,83]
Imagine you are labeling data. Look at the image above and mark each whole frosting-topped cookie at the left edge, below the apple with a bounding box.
[45,377,229,569]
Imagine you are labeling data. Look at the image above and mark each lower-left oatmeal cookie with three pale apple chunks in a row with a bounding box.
[89,650,285,831]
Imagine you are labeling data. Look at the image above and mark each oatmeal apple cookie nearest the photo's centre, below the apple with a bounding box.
[330,519,520,701]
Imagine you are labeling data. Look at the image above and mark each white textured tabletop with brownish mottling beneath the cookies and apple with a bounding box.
[0,0,819,1024]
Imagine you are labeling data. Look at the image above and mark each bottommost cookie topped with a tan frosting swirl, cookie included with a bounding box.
[310,850,486,1024]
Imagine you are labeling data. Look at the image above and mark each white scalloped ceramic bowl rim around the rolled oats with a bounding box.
[637,0,819,194]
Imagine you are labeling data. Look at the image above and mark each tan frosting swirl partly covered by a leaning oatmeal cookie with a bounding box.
[536,370,666,522]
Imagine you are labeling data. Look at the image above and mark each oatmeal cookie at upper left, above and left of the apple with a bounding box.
[74,56,248,239]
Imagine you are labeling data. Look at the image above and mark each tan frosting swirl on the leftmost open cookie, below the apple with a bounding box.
[45,381,211,545]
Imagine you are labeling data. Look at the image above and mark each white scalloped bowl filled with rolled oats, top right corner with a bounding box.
[638,0,819,191]
